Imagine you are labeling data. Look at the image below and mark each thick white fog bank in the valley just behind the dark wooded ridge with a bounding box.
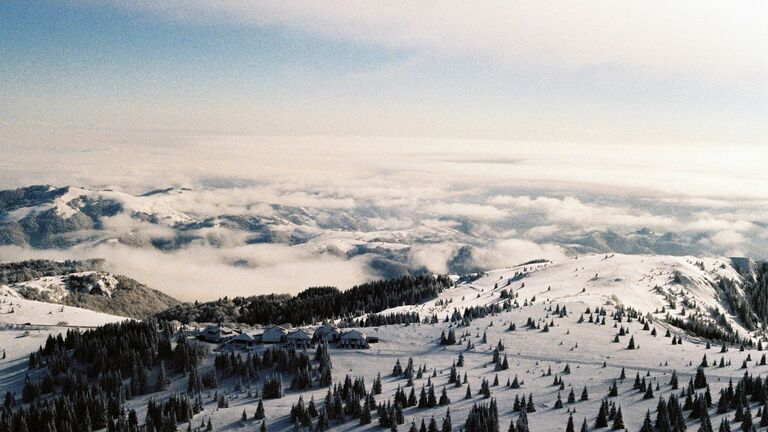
[0,245,374,301]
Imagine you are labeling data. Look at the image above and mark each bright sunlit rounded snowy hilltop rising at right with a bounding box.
[383,254,748,335]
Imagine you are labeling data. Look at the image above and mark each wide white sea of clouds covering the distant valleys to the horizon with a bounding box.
[0,129,768,299]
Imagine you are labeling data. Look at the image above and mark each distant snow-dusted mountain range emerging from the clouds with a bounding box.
[0,186,744,277]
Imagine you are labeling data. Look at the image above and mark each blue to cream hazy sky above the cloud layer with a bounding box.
[0,0,768,145]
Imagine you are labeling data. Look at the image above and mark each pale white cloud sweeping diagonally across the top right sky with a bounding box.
[97,0,768,82]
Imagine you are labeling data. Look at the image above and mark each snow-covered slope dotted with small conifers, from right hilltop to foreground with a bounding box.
[176,255,768,432]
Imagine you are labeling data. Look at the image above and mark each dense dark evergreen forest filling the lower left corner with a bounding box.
[6,320,213,432]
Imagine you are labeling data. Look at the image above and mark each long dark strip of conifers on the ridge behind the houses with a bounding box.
[157,275,452,325]
